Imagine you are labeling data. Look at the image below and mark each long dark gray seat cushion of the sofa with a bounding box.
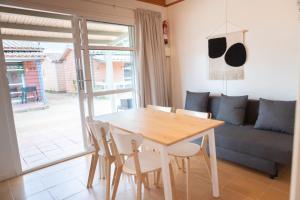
[215,124,293,164]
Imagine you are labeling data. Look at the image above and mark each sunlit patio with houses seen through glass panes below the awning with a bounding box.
[4,41,134,170]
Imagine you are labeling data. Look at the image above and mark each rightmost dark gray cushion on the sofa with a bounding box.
[255,99,296,134]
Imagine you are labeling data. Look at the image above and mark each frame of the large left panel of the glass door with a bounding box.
[0,6,90,175]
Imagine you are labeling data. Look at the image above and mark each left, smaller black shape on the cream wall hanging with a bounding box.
[208,37,227,58]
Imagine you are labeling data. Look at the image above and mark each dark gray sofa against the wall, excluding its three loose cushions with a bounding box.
[197,97,293,178]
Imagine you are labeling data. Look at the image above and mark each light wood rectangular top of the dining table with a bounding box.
[95,109,224,146]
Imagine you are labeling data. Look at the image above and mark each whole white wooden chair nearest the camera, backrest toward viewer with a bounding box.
[111,127,174,200]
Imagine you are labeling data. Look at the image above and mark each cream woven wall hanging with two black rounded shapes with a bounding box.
[208,31,247,80]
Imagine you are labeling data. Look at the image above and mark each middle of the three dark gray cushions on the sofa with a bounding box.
[217,95,248,125]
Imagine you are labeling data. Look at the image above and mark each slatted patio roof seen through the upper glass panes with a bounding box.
[0,7,130,46]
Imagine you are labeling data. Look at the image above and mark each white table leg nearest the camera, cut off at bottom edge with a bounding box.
[160,147,172,200]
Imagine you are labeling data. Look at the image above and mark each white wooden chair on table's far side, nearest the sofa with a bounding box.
[169,109,211,200]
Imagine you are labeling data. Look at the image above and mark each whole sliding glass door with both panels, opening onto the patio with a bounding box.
[0,7,137,171]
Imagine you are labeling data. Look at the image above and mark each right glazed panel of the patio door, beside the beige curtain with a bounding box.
[85,21,136,115]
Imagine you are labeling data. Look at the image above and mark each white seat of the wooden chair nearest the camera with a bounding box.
[123,151,161,174]
